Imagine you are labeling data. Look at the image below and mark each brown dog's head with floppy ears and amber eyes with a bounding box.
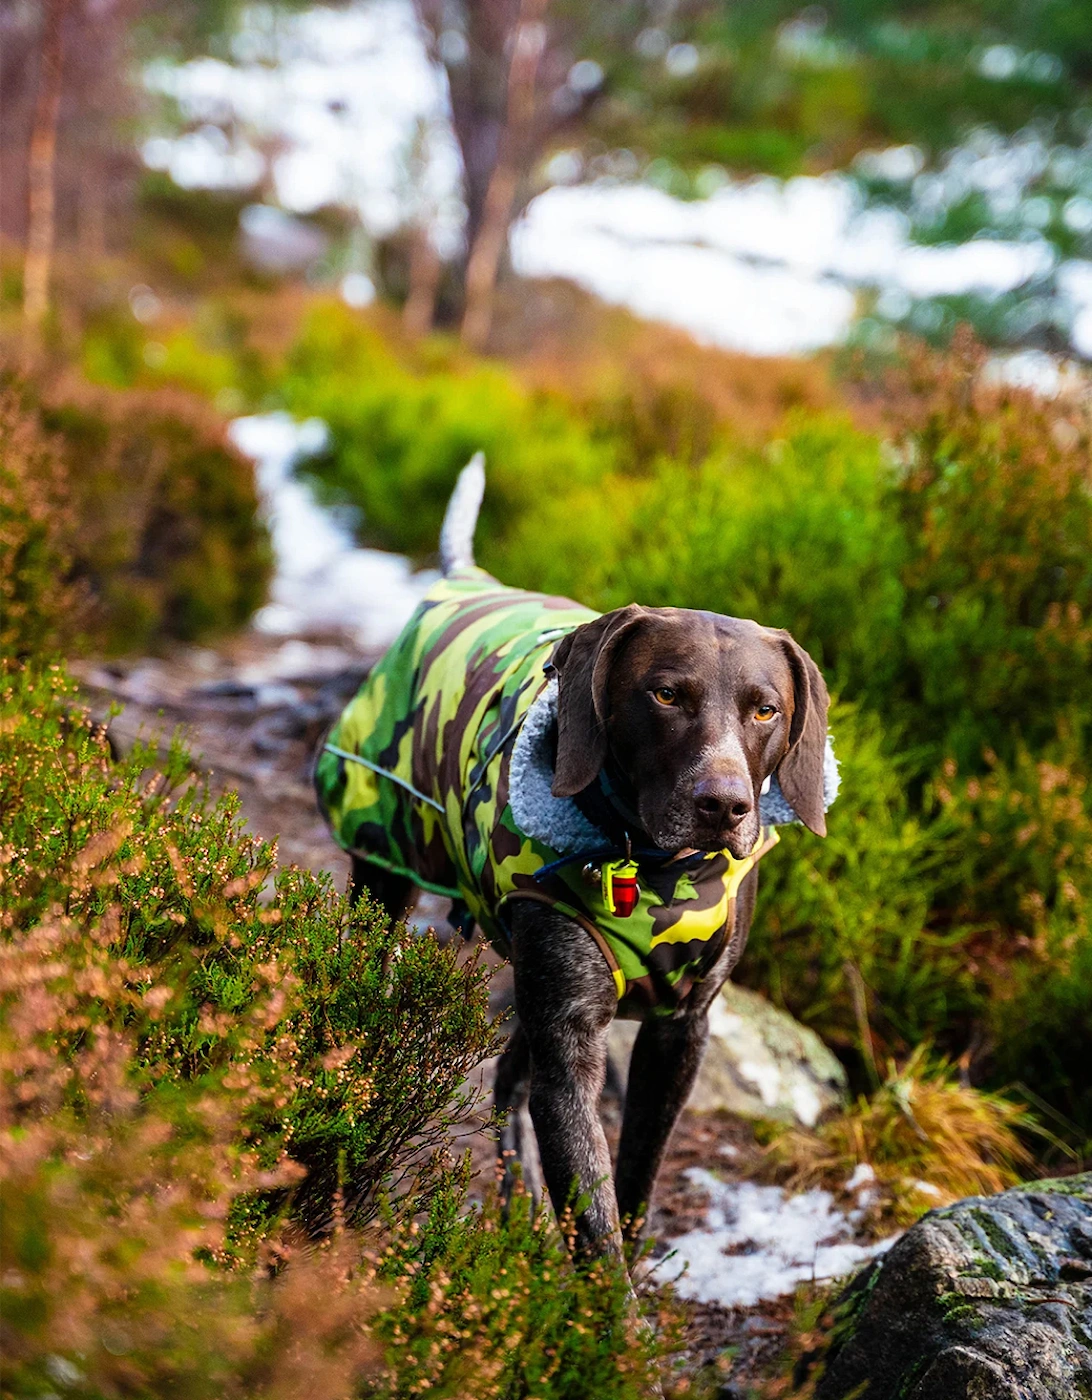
[553,603,827,857]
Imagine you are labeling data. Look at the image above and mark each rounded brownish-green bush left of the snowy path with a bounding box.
[0,381,270,651]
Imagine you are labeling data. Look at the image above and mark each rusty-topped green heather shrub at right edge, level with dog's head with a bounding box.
[868,339,1092,767]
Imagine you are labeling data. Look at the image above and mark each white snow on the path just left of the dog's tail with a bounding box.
[231,413,435,650]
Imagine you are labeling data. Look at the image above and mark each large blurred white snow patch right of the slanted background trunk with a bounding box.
[512,175,1054,354]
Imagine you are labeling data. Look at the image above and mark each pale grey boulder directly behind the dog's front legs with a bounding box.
[610,983,846,1127]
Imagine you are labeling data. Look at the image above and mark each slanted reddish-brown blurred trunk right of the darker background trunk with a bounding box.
[461,0,547,350]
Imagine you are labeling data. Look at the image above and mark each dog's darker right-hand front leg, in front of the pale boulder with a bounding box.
[615,1008,708,1238]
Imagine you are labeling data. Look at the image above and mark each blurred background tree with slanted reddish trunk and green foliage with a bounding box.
[414,0,1092,346]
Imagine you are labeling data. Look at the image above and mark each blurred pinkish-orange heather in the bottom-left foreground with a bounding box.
[0,914,378,1400]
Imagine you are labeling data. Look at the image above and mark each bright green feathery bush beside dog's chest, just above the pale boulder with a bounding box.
[738,704,981,1054]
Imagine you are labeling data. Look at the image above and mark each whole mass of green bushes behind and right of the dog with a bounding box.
[284,327,1092,1127]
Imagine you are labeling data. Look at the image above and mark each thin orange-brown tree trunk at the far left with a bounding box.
[22,0,70,332]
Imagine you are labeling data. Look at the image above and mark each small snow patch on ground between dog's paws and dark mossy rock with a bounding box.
[658,1168,895,1308]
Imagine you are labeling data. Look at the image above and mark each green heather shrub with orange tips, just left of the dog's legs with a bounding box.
[0,655,493,1228]
